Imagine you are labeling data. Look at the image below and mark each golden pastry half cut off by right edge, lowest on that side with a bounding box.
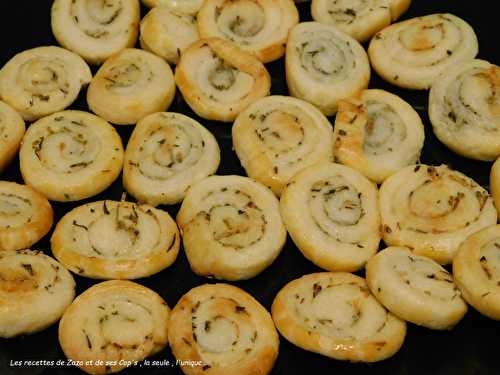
[453,225,500,320]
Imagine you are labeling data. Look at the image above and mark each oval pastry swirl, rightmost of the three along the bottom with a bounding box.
[272,272,406,362]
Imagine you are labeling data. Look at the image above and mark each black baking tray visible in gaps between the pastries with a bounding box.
[0,0,500,375]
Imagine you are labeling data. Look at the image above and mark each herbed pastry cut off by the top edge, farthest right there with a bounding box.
[311,0,411,42]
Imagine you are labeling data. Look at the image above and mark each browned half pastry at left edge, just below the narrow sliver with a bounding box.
[0,181,53,253]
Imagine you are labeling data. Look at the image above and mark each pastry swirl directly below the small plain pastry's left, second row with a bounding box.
[87,48,175,125]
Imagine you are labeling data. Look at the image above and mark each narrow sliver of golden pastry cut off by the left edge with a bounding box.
[0,101,26,172]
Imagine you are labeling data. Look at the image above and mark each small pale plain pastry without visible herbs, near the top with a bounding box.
[140,7,200,64]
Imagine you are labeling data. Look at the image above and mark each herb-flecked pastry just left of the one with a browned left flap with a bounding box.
[232,96,333,196]
